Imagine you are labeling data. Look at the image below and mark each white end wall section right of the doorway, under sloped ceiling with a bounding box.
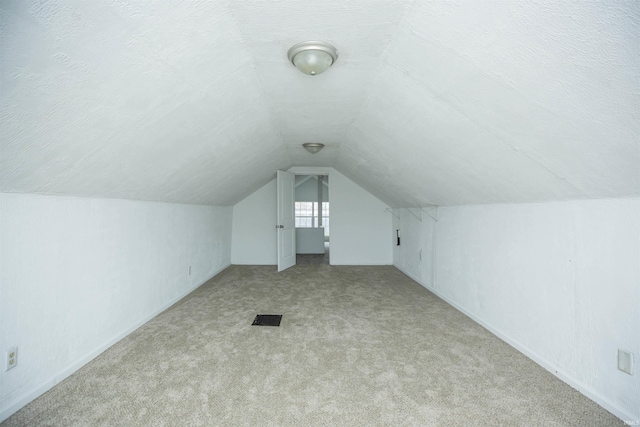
[329,171,393,265]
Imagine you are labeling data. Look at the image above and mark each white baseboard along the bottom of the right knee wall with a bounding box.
[394,265,640,425]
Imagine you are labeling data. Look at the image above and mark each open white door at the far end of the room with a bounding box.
[276,171,296,271]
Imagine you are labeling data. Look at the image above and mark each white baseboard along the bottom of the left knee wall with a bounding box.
[0,263,231,423]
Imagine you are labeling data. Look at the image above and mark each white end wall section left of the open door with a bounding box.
[231,179,278,265]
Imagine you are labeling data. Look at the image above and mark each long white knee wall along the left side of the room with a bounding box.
[0,194,231,420]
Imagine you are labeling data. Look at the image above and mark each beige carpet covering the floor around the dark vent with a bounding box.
[3,256,624,427]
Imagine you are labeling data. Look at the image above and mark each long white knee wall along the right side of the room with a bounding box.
[394,198,640,420]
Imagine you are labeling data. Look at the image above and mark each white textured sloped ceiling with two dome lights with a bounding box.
[0,0,640,206]
